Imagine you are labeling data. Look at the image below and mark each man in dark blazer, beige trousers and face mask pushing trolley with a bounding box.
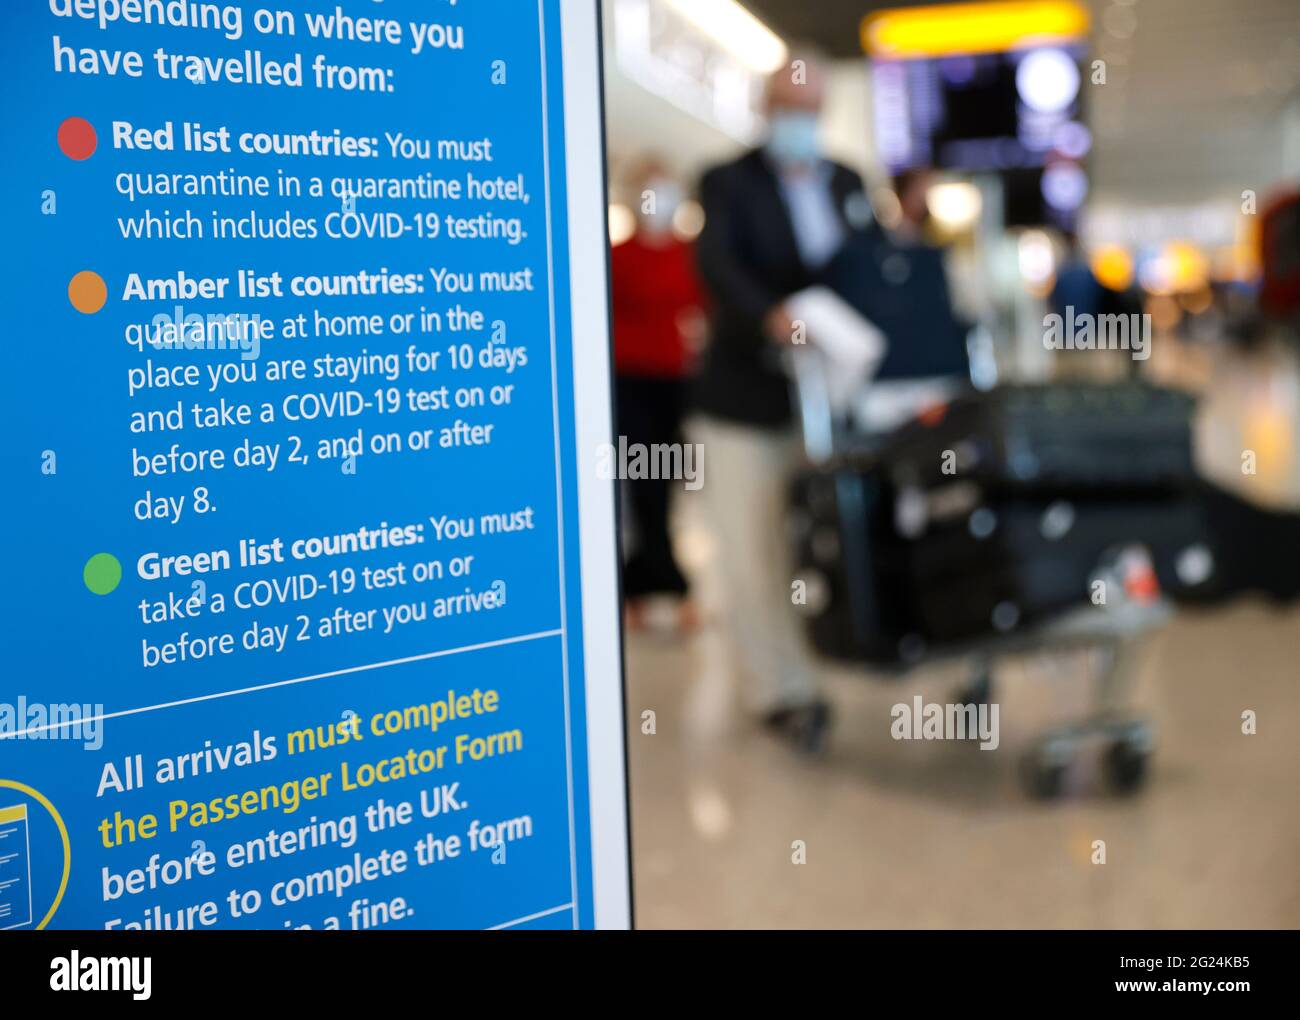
[697,57,868,751]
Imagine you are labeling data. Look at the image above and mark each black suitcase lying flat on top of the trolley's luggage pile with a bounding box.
[881,383,1195,494]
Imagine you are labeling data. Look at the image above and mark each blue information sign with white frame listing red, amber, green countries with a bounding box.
[0,0,629,930]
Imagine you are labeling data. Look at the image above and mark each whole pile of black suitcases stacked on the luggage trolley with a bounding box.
[793,369,1205,664]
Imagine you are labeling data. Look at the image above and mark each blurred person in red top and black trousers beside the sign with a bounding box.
[610,159,702,629]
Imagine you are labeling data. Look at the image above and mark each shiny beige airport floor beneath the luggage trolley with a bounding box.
[618,337,1300,928]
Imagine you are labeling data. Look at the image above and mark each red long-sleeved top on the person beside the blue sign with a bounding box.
[610,236,703,379]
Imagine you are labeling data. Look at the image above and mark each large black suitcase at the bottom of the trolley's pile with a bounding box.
[792,463,1205,657]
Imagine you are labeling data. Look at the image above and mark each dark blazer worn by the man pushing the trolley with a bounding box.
[696,149,870,426]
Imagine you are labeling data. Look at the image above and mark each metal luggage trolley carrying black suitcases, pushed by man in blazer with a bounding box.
[789,350,1173,798]
